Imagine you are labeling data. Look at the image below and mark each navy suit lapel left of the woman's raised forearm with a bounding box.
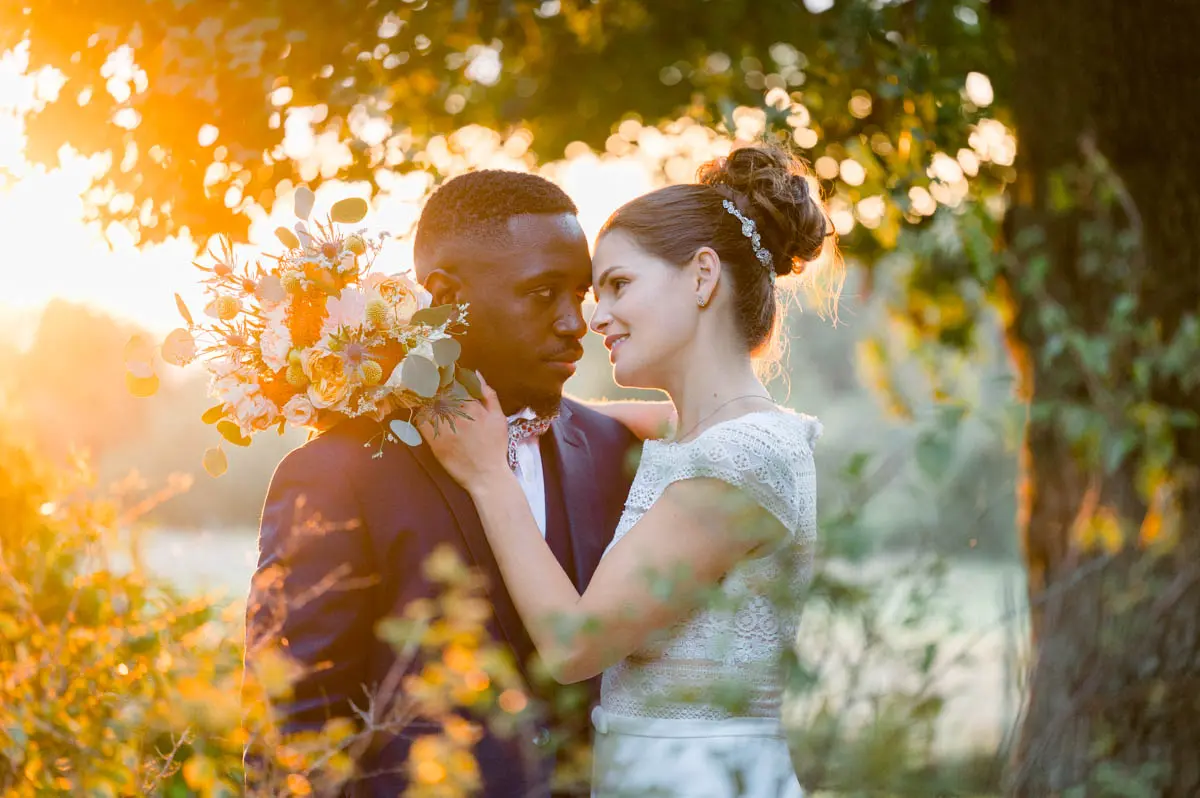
[410,444,533,668]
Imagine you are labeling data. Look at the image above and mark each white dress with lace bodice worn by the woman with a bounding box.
[593,410,821,798]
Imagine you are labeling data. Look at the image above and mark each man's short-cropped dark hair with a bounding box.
[413,169,580,274]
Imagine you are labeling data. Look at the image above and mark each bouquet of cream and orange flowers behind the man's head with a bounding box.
[138,188,479,475]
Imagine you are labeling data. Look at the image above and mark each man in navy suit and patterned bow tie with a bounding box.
[246,170,632,798]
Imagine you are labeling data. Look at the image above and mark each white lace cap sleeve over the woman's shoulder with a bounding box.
[666,413,821,533]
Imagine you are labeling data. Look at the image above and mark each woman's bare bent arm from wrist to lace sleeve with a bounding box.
[467,468,786,684]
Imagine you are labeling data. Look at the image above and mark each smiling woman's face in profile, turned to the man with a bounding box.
[590,230,698,389]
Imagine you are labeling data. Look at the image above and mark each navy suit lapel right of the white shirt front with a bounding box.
[552,402,611,593]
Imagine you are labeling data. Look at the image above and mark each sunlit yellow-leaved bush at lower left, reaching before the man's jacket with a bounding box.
[0,419,542,798]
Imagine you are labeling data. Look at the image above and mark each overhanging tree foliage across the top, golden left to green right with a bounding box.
[0,0,1008,249]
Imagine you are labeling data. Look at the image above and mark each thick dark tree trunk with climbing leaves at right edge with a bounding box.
[1008,0,1200,798]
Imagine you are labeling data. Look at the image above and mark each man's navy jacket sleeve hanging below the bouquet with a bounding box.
[246,438,376,734]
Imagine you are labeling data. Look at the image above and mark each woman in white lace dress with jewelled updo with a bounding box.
[427,145,839,798]
